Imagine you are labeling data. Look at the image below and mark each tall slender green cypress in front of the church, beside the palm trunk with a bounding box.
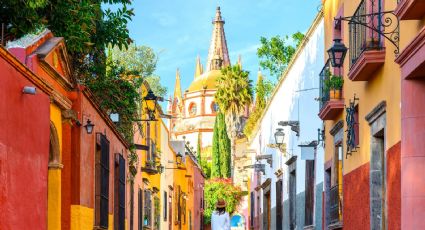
[218,113,232,178]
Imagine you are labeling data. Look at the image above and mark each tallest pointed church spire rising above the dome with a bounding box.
[207,7,230,71]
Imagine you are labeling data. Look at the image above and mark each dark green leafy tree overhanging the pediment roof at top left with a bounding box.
[0,0,134,80]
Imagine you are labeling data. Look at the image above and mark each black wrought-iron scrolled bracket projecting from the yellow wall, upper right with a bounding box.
[334,8,400,54]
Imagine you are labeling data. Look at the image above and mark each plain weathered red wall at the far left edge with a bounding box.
[0,47,50,229]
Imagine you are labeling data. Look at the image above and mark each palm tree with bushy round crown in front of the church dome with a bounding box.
[215,64,252,173]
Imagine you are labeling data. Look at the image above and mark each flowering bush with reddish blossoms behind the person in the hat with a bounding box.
[204,179,244,224]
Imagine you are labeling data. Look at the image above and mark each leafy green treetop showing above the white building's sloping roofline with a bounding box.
[257,32,304,79]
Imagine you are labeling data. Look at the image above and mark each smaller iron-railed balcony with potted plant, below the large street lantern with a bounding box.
[319,60,344,120]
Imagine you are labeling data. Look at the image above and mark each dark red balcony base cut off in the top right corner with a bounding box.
[394,0,425,20]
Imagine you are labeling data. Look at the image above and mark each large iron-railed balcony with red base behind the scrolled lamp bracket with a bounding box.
[348,0,385,81]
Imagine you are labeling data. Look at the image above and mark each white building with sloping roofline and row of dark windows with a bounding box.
[248,12,325,229]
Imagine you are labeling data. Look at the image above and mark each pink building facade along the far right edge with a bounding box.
[395,0,425,229]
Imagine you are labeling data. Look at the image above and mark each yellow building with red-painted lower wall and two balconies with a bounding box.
[319,0,401,229]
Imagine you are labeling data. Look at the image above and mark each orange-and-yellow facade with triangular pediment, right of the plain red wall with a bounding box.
[7,30,129,229]
